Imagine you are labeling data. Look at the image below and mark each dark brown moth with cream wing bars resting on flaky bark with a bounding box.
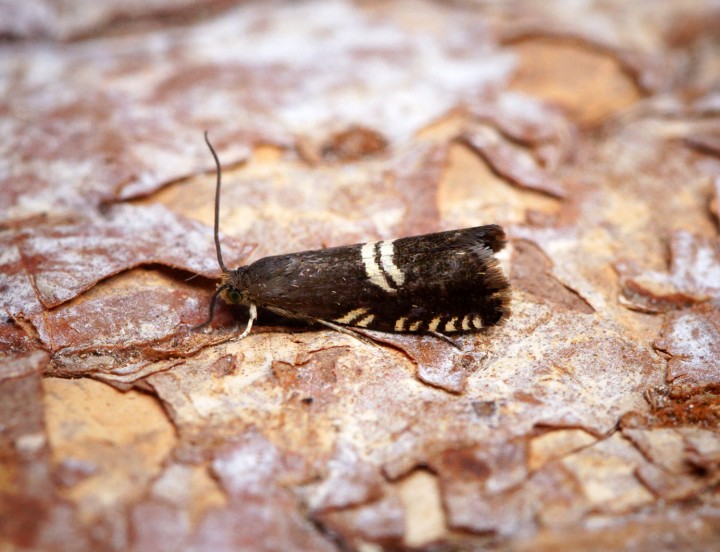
[201,132,510,339]
